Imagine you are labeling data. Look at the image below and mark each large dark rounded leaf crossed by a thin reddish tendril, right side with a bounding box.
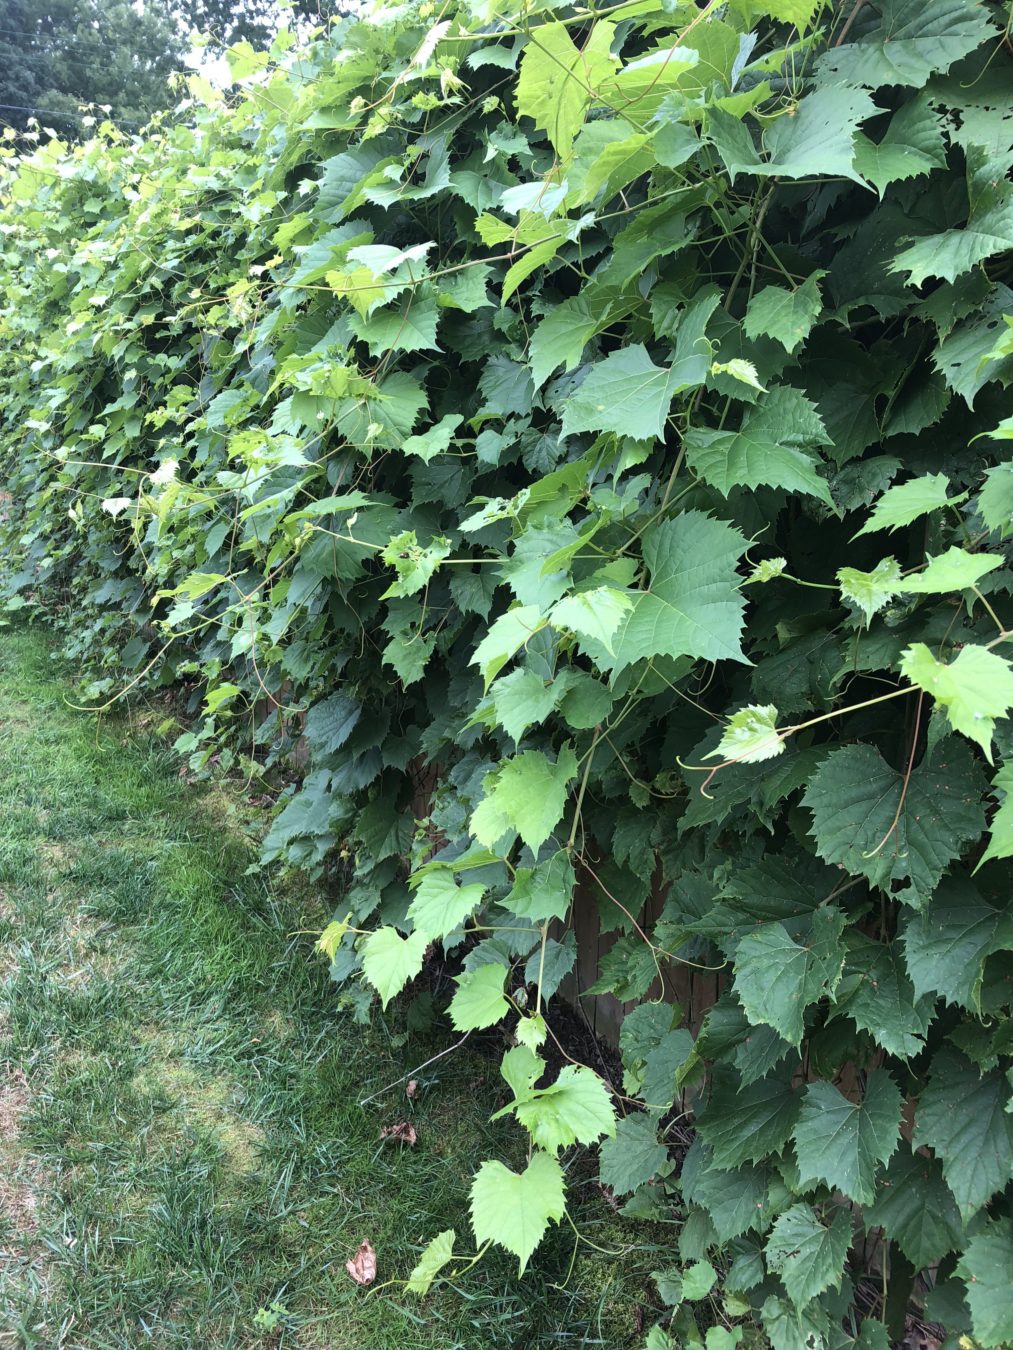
[802,737,985,909]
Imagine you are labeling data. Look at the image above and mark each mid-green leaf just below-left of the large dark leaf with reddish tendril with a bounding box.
[735,906,844,1046]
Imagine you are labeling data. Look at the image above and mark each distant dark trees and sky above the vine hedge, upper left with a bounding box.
[0,0,347,136]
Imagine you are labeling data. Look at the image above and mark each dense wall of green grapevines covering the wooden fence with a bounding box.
[0,0,1013,1350]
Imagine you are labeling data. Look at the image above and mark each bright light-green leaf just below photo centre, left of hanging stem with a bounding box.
[471,747,577,853]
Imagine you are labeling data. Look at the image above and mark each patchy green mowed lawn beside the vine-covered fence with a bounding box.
[0,629,674,1350]
